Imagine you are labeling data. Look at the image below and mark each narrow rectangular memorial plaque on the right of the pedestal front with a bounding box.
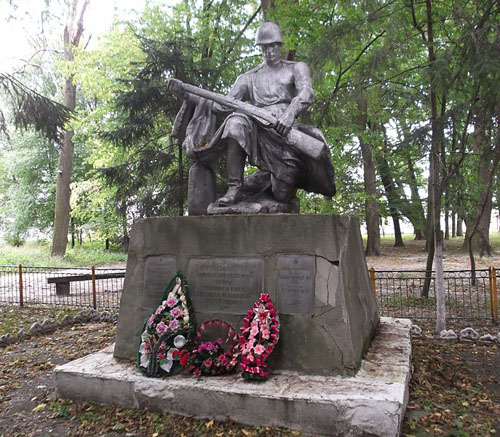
[276,255,315,314]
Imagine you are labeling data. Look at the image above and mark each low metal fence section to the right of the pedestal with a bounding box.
[370,268,498,321]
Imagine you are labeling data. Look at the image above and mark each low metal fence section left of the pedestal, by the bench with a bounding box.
[0,266,125,309]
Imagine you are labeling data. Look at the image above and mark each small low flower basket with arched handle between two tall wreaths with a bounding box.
[180,320,238,376]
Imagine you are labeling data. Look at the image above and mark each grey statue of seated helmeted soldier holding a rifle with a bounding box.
[169,22,335,214]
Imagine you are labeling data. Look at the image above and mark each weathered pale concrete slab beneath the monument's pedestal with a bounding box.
[55,318,411,436]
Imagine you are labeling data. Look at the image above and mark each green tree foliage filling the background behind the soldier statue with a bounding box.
[0,0,500,244]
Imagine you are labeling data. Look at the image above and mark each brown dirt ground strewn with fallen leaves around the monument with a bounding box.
[0,241,500,437]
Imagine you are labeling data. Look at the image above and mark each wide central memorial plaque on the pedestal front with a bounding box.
[187,258,264,314]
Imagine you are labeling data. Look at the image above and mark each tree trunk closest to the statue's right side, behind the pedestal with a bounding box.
[356,94,381,256]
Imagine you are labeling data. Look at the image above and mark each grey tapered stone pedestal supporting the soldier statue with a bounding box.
[114,214,378,375]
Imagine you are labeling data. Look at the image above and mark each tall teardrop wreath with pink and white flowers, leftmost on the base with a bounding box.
[141,272,195,376]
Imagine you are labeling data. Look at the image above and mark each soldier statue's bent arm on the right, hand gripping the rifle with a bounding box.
[276,62,314,136]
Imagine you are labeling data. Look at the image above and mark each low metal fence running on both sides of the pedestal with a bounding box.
[0,266,500,322]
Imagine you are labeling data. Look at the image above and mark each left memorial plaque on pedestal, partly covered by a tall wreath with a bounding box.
[142,256,177,311]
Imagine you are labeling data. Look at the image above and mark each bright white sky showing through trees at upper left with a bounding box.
[0,0,156,73]
